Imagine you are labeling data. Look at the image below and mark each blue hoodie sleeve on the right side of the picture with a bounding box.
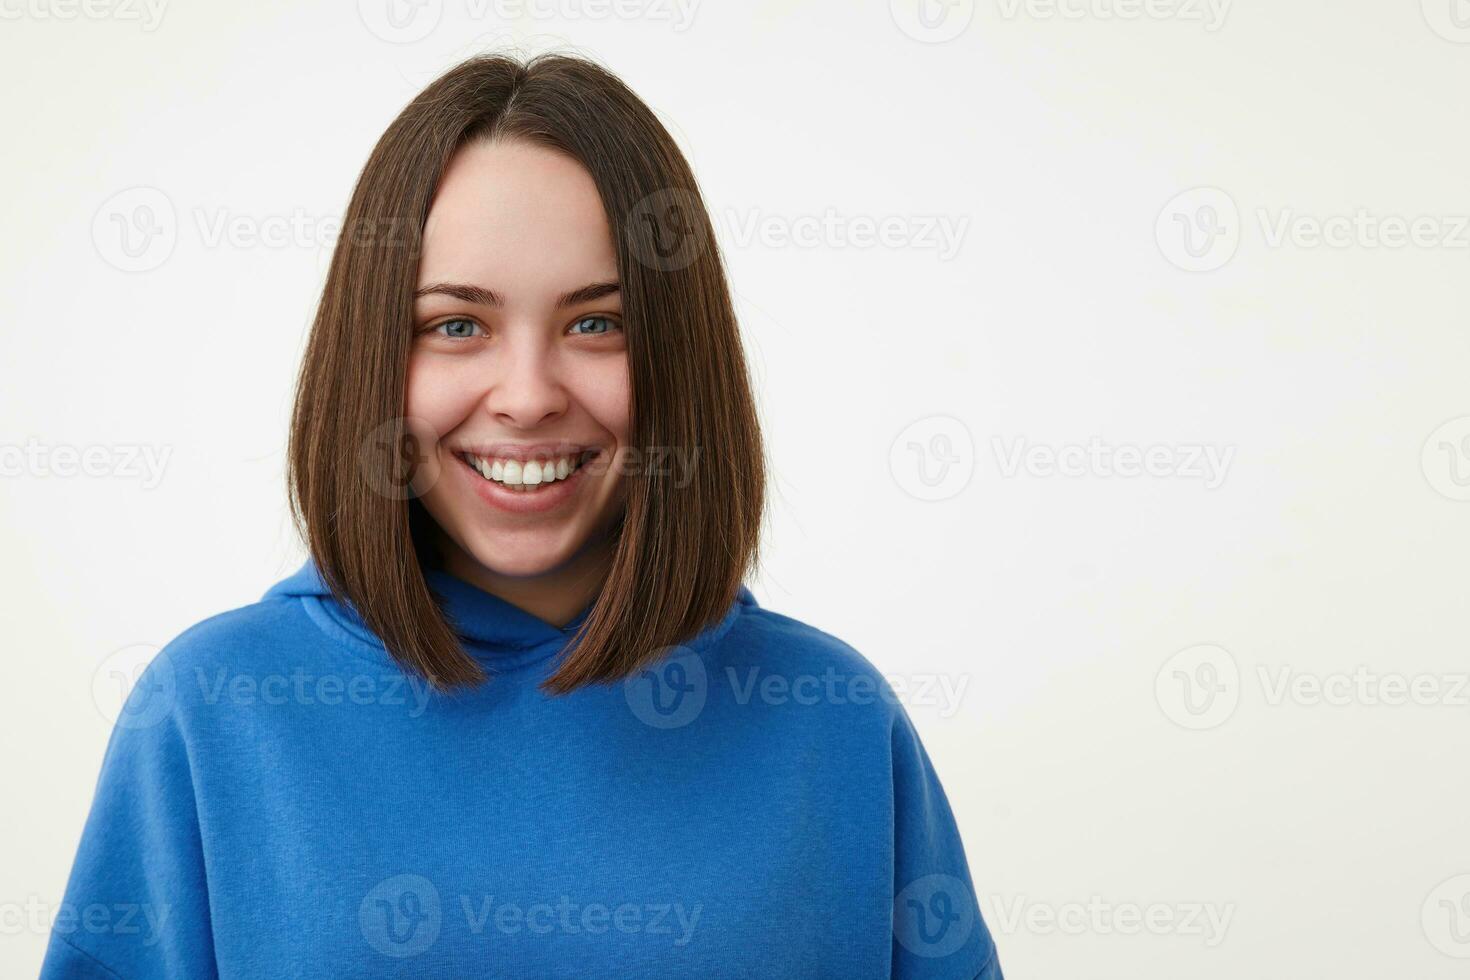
[892,702,1004,980]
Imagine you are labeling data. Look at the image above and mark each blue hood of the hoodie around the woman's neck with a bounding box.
[262,558,757,670]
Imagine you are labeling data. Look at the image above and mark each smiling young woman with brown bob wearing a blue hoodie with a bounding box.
[51,56,1001,980]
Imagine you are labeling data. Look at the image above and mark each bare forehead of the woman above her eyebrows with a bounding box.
[419,141,617,295]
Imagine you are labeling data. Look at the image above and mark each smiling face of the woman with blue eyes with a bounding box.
[404,141,629,576]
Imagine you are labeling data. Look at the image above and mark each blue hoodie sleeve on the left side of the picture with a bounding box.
[41,651,218,980]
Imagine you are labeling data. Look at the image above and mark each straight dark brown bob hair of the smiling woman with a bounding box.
[287,54,766,695]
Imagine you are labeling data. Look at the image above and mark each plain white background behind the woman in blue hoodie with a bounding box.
[0,0,1470,980]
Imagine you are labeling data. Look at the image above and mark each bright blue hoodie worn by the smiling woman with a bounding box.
[41,561,1001,980]
